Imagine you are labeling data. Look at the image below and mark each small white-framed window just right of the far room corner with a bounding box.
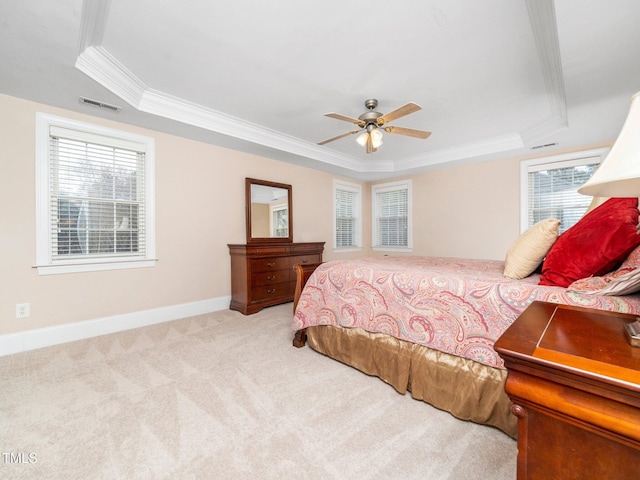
[372,180,411,251]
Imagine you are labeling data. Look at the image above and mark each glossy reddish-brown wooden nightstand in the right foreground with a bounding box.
[495,302,640,480]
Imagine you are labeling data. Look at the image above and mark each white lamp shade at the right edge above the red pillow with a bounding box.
[578,92,640,197]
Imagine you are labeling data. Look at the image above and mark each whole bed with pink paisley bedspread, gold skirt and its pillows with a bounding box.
[292,198,640,437]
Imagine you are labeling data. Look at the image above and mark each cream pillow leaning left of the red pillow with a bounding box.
[503,218,560,279]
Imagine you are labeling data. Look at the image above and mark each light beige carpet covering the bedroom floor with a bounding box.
[0,304,516,480]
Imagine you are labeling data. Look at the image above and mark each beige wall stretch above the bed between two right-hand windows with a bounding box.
[413,159,520,260]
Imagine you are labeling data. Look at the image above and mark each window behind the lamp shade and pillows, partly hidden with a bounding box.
[520,149,608,233]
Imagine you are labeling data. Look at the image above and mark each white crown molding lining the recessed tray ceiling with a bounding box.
[75,0,567,174]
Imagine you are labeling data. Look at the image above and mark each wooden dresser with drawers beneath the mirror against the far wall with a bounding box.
[229,242,324,315]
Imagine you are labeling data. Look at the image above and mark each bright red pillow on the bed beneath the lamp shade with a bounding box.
[539,197,640,287]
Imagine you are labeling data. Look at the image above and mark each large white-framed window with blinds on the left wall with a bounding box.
[36,113,155,274]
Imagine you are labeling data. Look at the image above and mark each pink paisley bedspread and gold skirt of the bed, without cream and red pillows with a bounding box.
[292,219,640,438]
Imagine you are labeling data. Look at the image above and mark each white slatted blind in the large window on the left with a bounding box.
[49,127,146,262]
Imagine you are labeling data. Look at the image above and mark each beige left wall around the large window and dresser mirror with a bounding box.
[0,95,360,335]
